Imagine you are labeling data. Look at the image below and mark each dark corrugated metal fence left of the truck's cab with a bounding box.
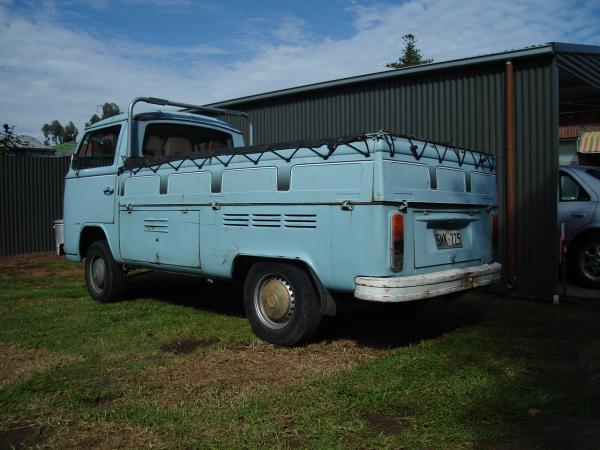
[0,155,70,256]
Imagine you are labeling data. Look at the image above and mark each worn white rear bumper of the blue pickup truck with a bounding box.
[354,262,502,303]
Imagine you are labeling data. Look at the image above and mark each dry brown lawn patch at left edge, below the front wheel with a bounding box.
[0,344,77,388]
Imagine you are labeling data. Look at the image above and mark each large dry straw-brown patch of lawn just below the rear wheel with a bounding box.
[138,341,383,400]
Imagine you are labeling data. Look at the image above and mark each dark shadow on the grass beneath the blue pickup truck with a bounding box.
[125,271,485,349]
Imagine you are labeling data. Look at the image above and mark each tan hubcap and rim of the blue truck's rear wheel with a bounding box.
[254,275,296,329]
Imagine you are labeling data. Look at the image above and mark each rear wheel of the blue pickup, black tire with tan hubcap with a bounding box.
[244,262,322,347]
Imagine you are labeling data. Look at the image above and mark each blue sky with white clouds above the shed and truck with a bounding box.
[0,0,600,138]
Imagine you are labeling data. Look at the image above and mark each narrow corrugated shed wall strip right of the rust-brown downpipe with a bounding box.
[515,60,558,296]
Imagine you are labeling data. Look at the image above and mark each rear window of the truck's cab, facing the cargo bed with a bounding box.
[142,123,233,157]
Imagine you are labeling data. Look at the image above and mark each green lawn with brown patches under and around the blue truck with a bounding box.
[0,256,600,449]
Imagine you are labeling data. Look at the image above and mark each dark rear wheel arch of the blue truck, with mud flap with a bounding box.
[231,255,337,316]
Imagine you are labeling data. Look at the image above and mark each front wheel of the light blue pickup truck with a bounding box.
[85,241,127,303]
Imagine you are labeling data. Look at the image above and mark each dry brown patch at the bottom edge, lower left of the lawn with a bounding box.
[44,420,165,449]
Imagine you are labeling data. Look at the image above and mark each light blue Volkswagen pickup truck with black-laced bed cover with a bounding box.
[63,97,501,346]
